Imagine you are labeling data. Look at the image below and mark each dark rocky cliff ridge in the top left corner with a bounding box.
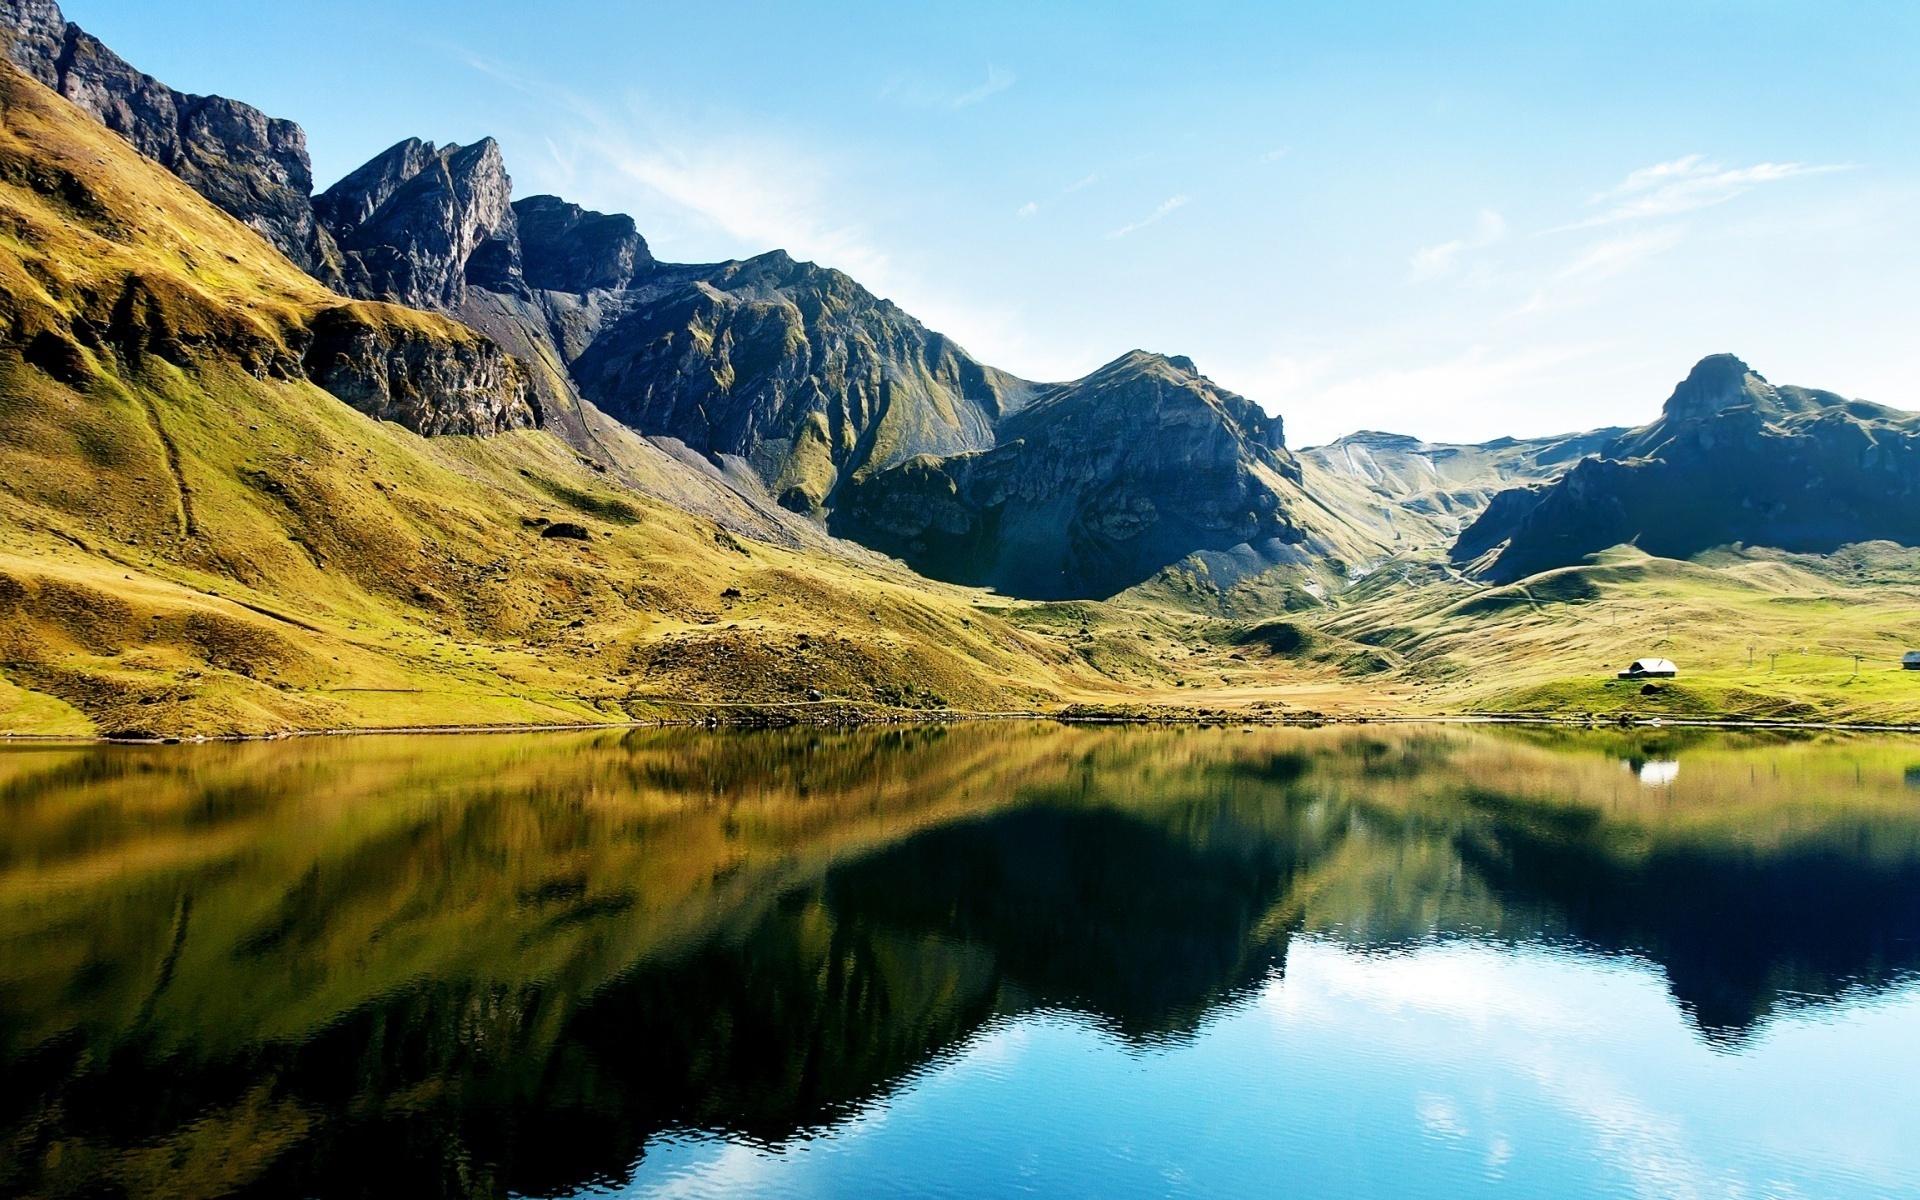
[0,0,332,280]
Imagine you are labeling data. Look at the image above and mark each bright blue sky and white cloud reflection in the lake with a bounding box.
[616,939,1920,1198]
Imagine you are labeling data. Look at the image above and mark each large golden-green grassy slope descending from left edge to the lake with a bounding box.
[0,69,1182,733]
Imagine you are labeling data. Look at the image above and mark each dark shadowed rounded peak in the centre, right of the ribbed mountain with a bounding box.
[831,351,1336,599]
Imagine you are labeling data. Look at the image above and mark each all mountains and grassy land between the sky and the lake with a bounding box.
[0,0,1920,737]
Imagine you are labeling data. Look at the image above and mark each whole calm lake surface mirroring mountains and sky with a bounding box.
[0,724,1920,1198]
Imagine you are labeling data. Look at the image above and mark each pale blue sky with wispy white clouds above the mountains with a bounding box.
[65,0,1920,445]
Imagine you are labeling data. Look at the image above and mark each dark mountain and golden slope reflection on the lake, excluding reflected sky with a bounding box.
[0,724,1920,1196]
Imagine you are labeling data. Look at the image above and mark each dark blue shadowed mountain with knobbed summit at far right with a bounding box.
[1453,355,1920,582]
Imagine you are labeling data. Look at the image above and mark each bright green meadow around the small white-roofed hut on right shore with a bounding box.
[1325,545,1920,724]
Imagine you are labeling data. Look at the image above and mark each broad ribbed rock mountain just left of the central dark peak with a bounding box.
[570,252,1031,513]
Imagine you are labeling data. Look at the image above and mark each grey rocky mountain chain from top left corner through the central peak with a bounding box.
[0,0,1377,597]
